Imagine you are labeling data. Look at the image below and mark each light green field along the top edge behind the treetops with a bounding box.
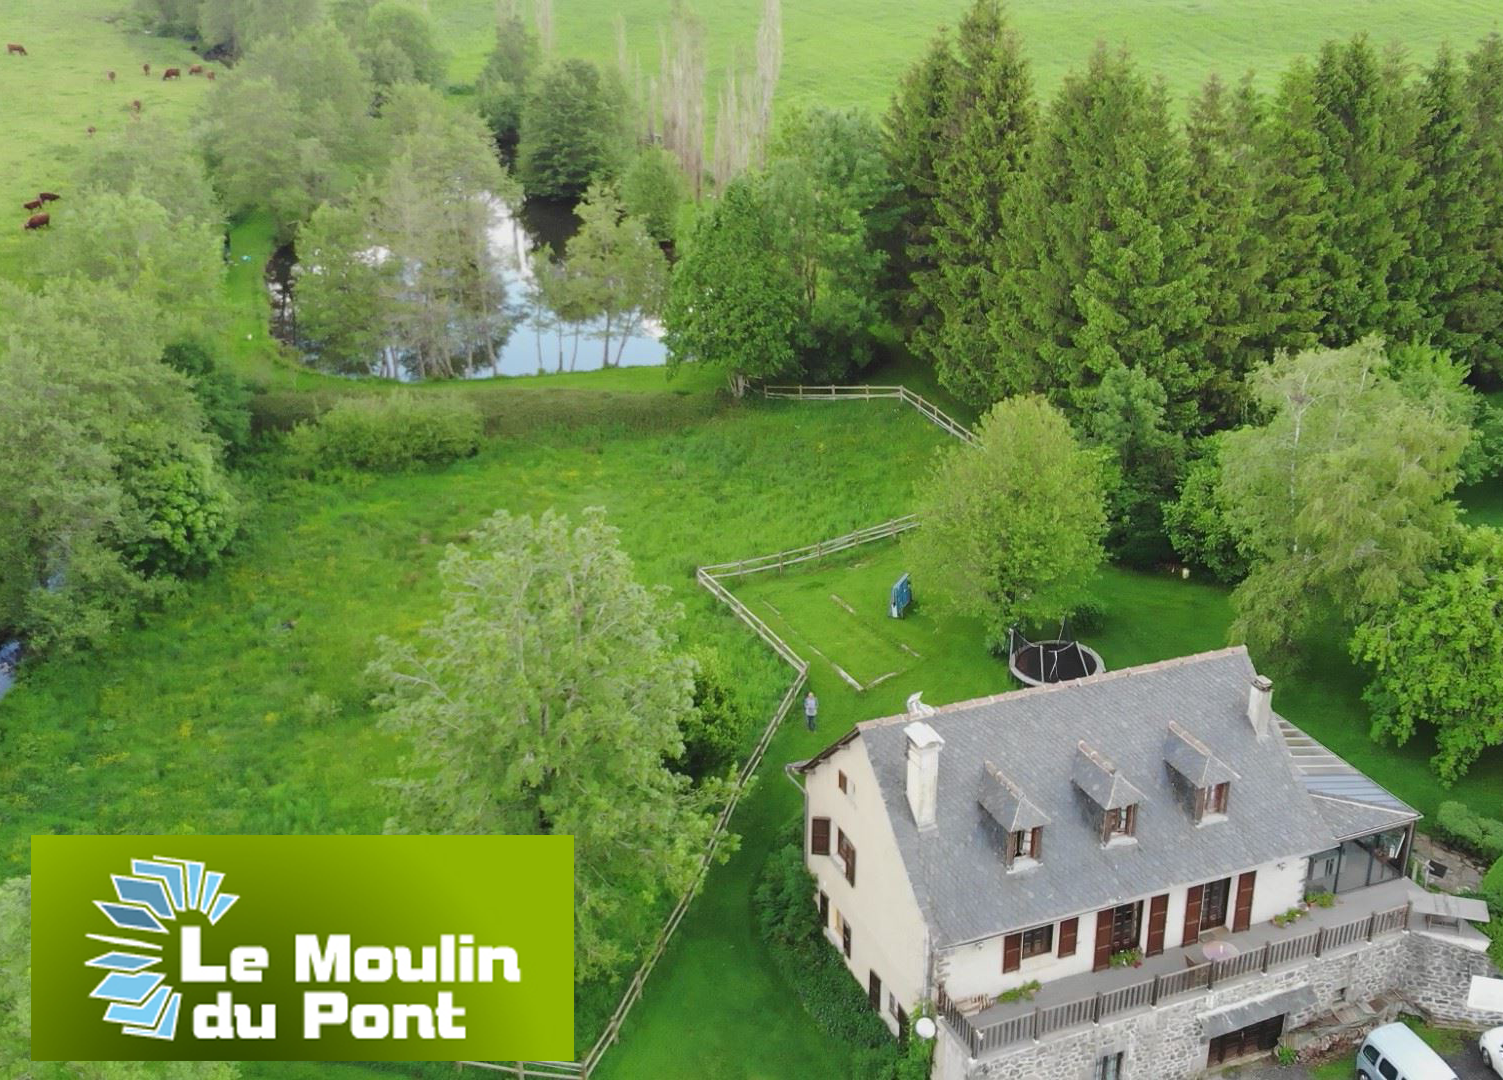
[430,0,1500,111]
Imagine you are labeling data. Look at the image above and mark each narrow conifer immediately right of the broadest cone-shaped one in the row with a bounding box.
[1186,75,1275,425]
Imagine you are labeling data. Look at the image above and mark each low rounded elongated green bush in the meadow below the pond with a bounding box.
[289,394,481,472]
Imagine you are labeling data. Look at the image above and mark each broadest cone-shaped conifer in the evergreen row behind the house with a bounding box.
[995,48,1213,433]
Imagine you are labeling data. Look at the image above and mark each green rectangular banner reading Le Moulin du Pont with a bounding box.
[32,837,574,1060]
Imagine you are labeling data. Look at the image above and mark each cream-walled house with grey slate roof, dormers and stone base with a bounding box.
[792,647,1489,1080]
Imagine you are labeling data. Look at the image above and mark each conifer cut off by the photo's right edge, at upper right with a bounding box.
[1456,33,1503,379]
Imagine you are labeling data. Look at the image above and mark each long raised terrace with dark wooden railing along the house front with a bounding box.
[938,879,1411,1057]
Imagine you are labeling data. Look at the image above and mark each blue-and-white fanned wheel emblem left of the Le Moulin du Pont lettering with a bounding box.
[84,856,239,1039]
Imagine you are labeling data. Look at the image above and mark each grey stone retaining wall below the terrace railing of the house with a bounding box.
[933,933,1498,1080]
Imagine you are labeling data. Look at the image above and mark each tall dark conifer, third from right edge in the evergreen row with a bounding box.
[1314,36,1422,345]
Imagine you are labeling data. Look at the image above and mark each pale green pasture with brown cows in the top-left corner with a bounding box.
[0,0,218,278]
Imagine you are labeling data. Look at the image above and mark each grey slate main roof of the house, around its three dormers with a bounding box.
[847,646,1417,948]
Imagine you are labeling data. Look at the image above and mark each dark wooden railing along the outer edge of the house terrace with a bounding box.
[936,904,1410,1057]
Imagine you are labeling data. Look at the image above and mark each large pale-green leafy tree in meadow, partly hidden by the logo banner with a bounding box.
[371,511,724,981]
